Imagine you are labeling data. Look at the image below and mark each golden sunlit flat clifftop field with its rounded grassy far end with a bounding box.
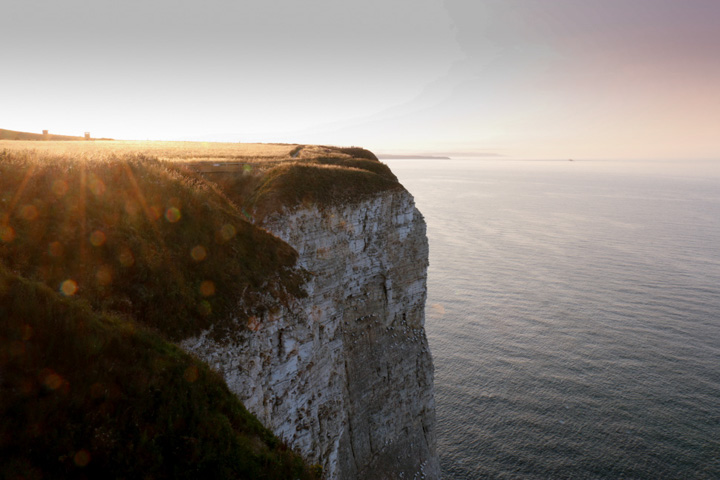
[0,140,402,221]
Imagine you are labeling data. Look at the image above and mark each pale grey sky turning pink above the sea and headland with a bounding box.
[0,0,720,160]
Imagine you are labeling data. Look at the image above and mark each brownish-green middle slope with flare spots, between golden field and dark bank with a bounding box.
[0,152,304,340]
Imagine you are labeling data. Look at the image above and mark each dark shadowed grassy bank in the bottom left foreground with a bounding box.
[0,267,317,479]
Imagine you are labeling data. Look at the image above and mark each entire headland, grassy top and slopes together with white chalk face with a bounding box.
[0,140,439,479]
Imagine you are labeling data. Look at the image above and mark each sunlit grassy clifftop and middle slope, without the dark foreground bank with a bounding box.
[0,141,402,340]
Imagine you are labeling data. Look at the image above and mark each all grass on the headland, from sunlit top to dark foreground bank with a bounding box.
[0,142,402,478]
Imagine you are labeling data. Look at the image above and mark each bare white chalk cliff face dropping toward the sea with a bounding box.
[182,189,439,479]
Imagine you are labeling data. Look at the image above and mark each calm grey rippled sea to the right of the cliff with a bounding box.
[387,160,720,479]
